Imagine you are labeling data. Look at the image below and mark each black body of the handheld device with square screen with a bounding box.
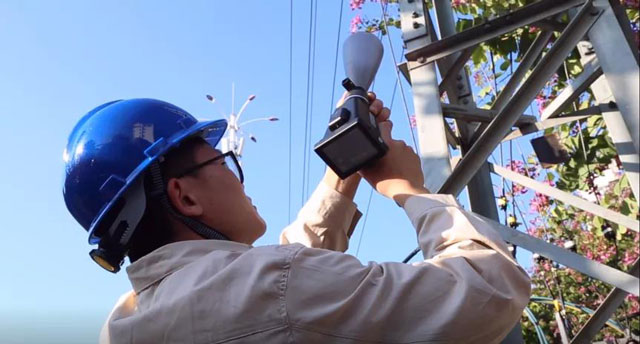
[314,78,389,179]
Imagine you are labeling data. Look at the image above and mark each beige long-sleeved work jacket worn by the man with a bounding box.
[100,185,530,344]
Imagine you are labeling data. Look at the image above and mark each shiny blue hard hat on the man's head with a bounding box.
[63,99,227,244]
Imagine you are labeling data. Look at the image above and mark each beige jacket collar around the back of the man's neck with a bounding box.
[127,240,252,294]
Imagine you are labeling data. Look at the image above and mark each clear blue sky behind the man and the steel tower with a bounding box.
[0,0,528,343]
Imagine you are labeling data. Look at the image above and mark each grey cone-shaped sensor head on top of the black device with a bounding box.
[342,32,383,90]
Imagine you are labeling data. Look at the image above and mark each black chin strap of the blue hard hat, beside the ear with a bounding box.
[149,161,229,240]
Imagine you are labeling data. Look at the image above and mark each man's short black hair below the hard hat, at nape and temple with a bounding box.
[128,137,208,263]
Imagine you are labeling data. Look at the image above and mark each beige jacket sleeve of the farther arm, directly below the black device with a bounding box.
[280,183,362,252]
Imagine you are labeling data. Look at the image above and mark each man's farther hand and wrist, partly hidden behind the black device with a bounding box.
[323,92,391,200]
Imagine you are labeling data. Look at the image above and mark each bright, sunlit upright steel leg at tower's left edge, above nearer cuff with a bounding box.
[399,0,451,194]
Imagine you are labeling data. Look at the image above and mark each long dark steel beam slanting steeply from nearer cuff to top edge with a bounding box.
[438,1,600,195]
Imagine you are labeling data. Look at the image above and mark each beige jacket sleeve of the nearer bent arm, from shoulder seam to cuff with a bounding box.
[285,195,530,343]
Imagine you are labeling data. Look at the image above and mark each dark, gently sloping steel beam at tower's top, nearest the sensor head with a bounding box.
[405,0,585,63]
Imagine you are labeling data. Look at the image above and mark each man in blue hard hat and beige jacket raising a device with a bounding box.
[65,94,530,343]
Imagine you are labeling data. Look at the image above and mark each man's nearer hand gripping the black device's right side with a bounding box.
[359,121,429,206]
